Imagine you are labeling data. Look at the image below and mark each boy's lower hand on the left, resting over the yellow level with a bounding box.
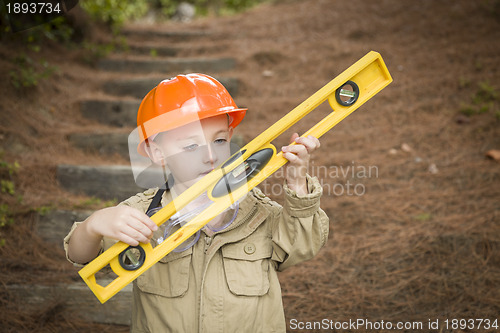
[87,206,158,246]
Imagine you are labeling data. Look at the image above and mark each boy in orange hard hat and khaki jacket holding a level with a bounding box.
[65,74,329,333]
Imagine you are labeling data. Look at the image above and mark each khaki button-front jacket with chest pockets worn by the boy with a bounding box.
[65,176,329,333]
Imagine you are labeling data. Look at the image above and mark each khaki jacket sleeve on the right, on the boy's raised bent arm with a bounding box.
[272,175,329,271]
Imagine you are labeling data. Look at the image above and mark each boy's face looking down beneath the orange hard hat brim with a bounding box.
[151,115,233,188]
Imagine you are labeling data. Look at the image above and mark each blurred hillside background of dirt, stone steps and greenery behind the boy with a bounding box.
[0,0,500,332]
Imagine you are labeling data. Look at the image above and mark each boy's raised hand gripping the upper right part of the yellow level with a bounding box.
[281,133,320,195]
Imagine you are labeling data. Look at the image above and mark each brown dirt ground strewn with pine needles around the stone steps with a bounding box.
[0,0,500,332]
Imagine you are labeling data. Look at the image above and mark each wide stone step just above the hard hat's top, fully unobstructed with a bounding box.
[98,58,236,74]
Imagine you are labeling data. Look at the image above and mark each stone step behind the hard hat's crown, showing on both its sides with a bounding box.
[102,76,239,98]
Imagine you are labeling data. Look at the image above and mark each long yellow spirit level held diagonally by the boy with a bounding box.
[79,51,392,303]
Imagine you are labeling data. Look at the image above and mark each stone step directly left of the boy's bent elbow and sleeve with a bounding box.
[35,210,92,245]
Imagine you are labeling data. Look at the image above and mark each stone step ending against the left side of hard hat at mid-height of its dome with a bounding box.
[80,98,139,127]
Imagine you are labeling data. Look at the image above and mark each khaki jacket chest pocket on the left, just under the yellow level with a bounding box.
[137,248,193,297]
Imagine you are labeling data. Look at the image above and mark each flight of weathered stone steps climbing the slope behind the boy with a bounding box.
[28,24,242,325]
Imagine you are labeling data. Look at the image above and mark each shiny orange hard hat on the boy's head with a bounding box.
[137,74,247,156]
